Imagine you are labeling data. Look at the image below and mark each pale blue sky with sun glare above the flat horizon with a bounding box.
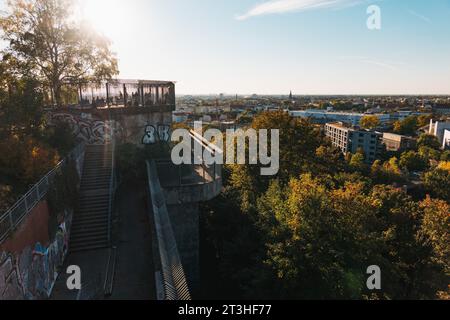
[0,0,450,95]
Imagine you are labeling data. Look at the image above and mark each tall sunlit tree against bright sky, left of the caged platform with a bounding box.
[0,0,118,106]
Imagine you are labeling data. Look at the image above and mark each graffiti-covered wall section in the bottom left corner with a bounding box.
[0,215,69,300]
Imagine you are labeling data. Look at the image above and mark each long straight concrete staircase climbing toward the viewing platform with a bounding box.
[69,144,113,252]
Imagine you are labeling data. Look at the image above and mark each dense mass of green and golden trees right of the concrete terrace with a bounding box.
[202,113,450,299]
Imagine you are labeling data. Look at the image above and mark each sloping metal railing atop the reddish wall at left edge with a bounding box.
[0,143,85,243]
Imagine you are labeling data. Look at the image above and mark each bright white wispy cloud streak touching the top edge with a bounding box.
[235,0,366,20]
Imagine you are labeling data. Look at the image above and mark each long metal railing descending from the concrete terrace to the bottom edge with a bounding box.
[147,161,191,300]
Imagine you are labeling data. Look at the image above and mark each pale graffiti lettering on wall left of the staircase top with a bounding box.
[49,113,118,144]
